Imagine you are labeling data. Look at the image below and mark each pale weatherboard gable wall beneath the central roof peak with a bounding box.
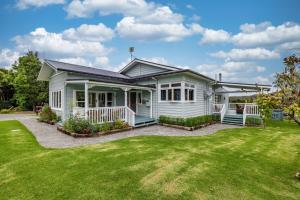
[125,63,169,77]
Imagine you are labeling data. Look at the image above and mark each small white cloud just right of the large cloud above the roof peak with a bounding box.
[200,28,230,44]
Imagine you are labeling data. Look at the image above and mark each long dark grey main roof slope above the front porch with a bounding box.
[45,60,130,79]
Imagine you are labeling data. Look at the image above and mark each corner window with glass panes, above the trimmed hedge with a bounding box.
[160,83,195,101]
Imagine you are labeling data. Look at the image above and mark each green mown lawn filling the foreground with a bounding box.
[0,121,300,200]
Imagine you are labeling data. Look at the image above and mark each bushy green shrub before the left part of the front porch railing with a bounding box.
[63,117,97,134]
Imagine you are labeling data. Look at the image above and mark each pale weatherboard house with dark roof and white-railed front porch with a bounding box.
[38,59,269,126]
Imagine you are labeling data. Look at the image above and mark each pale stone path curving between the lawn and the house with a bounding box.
[0,114,241,148]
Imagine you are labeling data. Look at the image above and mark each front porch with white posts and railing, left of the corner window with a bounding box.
[66,80,156,127]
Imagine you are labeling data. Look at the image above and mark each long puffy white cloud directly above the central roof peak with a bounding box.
[116,17,193,42]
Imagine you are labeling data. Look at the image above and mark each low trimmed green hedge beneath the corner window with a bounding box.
[159,115,218,127]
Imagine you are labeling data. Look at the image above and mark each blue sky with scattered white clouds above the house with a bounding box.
[0,0,300,83]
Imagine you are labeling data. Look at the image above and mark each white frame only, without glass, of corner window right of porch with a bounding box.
[158,81,197,103]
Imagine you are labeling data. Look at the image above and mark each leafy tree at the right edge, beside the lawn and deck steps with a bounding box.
[275,55,300,125]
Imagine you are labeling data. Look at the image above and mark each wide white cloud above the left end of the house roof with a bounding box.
[14,27,110,57]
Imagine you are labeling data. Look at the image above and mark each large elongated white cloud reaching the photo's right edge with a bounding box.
[232,22,300,47]
